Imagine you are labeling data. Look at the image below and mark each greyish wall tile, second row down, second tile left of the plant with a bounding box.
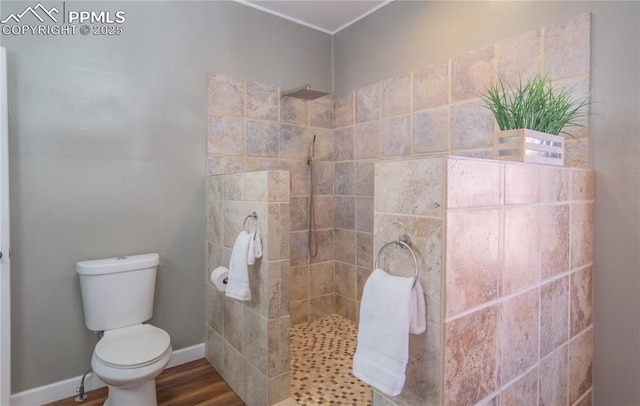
[413,106,450,154]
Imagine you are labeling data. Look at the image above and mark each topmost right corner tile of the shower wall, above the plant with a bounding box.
[542,13,591,80]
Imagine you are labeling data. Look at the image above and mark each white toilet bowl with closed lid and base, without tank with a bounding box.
[91,324,172,405]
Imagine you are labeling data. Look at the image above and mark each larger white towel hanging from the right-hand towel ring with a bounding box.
[353,269,426,396]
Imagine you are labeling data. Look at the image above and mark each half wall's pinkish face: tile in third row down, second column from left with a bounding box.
[500,289,540,383]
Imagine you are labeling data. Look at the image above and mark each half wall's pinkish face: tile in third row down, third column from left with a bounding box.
[540,277,569,357]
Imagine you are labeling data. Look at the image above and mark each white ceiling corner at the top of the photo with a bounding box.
[236,0,393,34]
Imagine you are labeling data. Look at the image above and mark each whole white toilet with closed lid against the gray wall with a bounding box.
[76,254,172,406]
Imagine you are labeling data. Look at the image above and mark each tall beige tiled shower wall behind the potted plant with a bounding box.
[334,13,590,320]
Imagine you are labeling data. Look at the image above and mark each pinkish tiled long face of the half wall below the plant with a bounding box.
[443,159,594,406]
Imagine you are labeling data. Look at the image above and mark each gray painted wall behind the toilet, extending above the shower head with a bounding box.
[2,1,331,393]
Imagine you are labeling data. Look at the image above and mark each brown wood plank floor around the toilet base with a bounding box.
[46,358,244,406]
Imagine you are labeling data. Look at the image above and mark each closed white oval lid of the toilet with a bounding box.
[95,324,171,368]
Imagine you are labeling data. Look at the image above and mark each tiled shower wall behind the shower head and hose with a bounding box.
[207,74,337,324]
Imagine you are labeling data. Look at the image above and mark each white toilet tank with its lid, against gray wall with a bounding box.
[76,253,159,331]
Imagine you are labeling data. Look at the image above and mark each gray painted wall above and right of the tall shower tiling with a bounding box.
[334,1,640,406]
